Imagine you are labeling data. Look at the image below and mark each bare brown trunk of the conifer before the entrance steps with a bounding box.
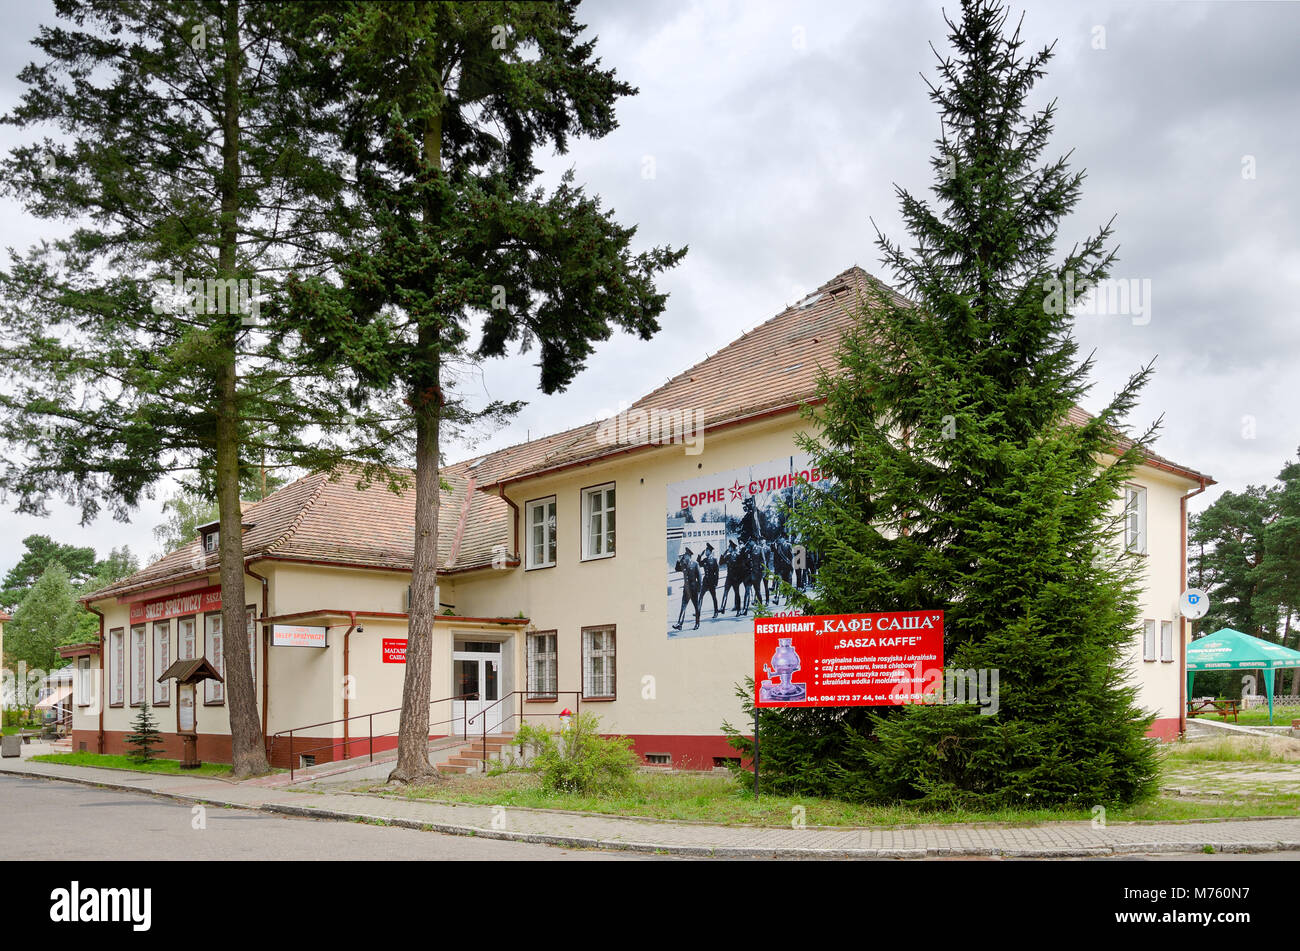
[389,107,442,782]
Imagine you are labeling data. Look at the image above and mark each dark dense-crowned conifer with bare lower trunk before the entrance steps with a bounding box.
[283,3,685,782]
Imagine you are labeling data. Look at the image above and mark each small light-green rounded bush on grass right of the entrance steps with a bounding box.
[515,713,640,795]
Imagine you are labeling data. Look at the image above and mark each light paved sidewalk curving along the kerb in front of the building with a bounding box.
[0,759,1300,859]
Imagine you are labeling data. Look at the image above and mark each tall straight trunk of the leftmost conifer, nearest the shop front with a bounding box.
[212,0,270,780]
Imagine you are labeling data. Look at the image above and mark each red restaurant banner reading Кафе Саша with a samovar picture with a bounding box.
[754,611,944,707]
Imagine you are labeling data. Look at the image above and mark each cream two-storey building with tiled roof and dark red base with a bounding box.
[74,269,1210,768]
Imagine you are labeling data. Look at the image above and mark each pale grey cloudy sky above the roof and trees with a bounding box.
[0,0,1300,572]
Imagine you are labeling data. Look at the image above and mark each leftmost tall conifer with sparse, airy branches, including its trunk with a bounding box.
[0,0,402,776]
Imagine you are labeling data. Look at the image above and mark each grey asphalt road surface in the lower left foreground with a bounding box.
[0,776,663,861]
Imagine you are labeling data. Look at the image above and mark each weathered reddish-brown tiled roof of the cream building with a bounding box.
[91,268,1201,598]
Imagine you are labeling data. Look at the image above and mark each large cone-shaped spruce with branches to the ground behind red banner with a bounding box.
[792,0,1156,807]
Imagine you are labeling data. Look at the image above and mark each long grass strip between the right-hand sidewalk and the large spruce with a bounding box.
[358,744,1300,828]
